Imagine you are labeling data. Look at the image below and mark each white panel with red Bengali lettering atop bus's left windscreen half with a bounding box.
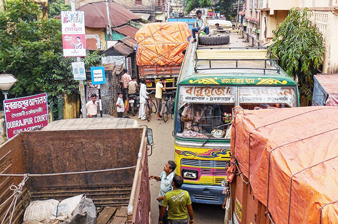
[179,86,235,107]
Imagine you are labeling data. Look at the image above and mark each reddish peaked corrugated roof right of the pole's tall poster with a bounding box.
[78,2,141,28]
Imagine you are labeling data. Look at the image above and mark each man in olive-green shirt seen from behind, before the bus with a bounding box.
[158,175,194,224]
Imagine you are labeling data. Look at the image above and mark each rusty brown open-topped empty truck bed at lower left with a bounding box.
[0,117,152,224]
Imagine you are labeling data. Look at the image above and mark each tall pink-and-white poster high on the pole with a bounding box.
[61,11,86,57]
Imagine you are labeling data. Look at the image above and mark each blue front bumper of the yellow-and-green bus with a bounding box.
[181,184,225,205]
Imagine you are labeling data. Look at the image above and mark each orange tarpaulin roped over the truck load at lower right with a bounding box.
[231,107,338,224]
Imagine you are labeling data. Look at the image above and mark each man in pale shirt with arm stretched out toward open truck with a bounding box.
[149,160,176,224]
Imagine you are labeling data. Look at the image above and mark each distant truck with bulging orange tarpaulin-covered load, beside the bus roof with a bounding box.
[135,22,191,90]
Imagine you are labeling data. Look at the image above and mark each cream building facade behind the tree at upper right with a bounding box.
[245,0,338,74]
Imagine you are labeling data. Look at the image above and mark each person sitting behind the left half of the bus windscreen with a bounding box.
[181,103,201,132]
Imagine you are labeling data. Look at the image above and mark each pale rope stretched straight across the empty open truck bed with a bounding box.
[0,166,136,177]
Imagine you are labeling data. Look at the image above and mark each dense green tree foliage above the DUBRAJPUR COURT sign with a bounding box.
[0,0,100,115]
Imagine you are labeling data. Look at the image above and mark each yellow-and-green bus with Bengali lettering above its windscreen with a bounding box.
[173,33,299,205]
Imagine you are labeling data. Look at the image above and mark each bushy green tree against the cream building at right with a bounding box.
[269,8,325,104]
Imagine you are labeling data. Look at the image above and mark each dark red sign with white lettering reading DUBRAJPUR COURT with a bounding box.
[4,93,48,139]
